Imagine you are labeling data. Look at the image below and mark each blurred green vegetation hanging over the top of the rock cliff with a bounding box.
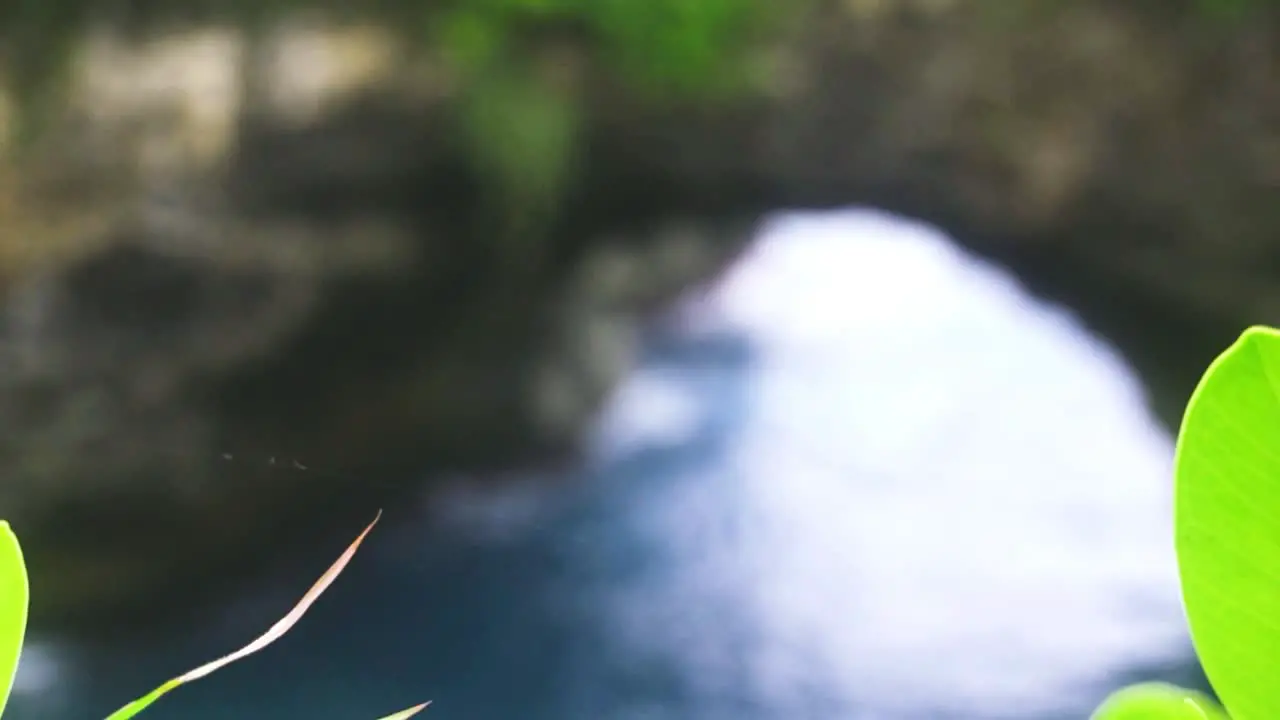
[0,0,783,240]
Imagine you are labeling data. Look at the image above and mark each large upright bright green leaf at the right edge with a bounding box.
[1174,327,1280,720]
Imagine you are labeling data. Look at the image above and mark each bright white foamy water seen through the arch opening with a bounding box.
[588,211,1189,717]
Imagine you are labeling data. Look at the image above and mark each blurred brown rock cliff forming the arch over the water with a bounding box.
[0,1,1280,623]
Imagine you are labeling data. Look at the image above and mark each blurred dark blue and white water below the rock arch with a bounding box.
[6,213,1196,720]
